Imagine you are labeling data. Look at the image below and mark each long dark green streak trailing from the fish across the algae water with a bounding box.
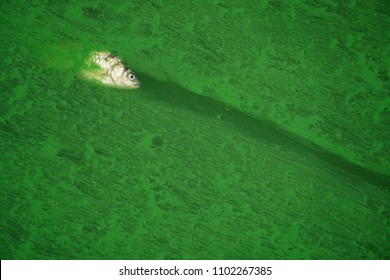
[137,73,390,190]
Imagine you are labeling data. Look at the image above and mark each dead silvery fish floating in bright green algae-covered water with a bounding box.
[83,51,141,89]
